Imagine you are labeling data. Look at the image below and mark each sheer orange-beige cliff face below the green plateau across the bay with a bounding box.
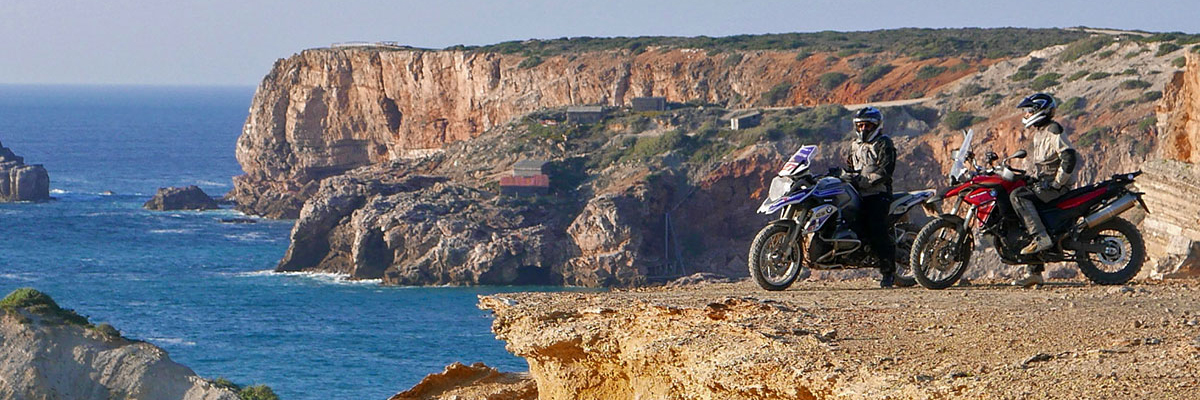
[233,48,979,217]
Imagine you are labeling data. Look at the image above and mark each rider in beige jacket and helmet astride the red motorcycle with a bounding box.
[1009,92,1080,287]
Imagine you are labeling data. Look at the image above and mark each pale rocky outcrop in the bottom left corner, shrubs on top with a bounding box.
[0,289,238,400]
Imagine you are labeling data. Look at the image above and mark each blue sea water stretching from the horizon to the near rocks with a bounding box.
[0,85,571,399]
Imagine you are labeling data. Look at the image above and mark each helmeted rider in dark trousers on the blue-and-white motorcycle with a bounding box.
[847,107,896,287]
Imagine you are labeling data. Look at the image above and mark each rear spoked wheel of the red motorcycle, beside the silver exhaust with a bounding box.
[1075,219,1146,285]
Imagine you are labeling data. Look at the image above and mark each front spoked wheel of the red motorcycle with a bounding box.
[908,219,974,289]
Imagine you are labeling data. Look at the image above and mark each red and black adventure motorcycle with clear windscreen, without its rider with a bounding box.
[910,150,1148,289]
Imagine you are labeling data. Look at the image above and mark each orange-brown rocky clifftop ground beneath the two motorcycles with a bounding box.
[436,280,1200,400]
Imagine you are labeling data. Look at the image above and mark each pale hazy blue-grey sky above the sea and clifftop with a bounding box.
[0,0,1200,86]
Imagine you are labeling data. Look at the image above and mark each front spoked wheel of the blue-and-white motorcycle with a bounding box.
[749,225,804,291]
